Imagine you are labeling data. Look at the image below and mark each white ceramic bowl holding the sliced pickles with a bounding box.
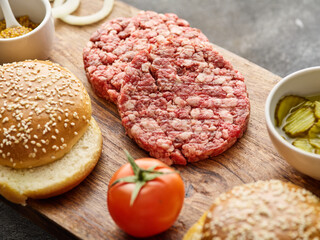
[265,66,320,180]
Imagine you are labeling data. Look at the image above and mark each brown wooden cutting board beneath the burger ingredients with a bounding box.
[3,0,320,240]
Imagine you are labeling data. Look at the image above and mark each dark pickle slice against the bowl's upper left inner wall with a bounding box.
[275,96,306,127]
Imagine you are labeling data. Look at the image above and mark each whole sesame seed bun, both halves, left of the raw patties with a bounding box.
[0,60,102,205]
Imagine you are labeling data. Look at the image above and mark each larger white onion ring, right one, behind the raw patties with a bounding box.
[54,0,114,25]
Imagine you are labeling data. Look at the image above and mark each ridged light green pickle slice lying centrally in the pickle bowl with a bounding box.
[283,107,315,137]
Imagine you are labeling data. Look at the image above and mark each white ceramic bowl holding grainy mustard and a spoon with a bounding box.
[0,0,54,64]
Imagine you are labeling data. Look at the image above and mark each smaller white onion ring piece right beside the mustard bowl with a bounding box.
[52,0,80,18]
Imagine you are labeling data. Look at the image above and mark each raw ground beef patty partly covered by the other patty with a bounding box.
[83,11,208,103]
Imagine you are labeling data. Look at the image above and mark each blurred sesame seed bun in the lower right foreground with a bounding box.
[184,180,320,240]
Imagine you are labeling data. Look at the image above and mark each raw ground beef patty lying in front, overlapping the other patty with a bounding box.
[118,37,250,165]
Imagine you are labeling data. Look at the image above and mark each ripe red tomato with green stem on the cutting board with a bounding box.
[107,158,184,237]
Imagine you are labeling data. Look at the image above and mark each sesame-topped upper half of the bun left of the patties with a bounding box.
[0,60,91,168]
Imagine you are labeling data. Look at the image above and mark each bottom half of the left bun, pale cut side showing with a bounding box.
[0,117,102,205]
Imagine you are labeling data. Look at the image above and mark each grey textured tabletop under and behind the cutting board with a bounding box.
[0,0,320,239]
